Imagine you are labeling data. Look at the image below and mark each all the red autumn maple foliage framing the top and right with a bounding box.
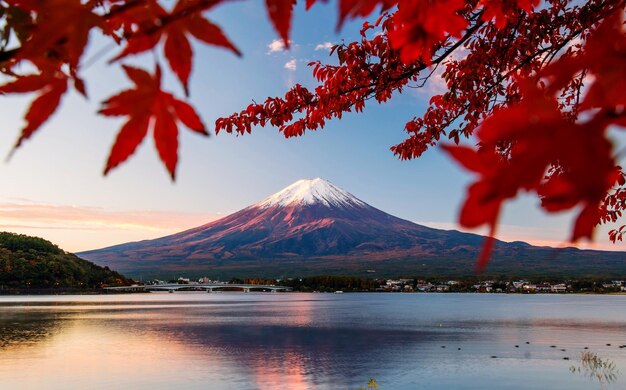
[0,0,626,269]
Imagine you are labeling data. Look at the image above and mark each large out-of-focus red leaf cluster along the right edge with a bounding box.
[447,13,626,262]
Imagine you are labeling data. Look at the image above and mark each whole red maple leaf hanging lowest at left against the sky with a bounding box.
[99,65,209,180]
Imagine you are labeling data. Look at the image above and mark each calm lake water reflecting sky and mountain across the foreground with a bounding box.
[0,292,626,390]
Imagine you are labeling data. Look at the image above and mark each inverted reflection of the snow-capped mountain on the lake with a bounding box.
[85,303,466,389]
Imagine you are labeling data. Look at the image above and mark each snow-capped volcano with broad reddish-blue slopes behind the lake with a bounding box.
[78,178,626,277]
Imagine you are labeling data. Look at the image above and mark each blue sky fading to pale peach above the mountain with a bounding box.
[0,2,626,251]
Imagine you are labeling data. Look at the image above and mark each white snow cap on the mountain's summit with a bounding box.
[258,177,366,208]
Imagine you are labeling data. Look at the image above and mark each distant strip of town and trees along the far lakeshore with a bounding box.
[135,276,626,294]
